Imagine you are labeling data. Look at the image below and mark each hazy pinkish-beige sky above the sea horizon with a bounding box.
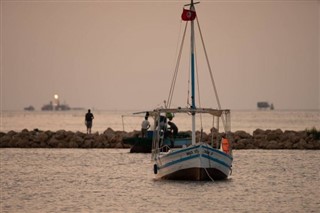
[1,0,320,110]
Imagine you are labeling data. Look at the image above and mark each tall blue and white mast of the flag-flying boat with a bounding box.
[190,0,196,145]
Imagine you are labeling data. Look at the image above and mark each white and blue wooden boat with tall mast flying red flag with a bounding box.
[148,0,233,181]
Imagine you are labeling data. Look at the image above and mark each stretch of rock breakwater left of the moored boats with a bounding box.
[0,128,129,148]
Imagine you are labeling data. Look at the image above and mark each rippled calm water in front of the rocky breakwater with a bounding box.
[0,149,320,213]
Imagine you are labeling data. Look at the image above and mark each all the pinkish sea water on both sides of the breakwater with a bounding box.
[0,111,320,213]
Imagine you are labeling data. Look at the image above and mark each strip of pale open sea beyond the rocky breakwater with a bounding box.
[0,110,320,133]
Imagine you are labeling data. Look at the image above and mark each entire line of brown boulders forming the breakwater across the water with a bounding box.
[0,128,320,150]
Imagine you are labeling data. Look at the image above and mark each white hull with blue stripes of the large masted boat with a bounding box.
[155,143,233,180]
